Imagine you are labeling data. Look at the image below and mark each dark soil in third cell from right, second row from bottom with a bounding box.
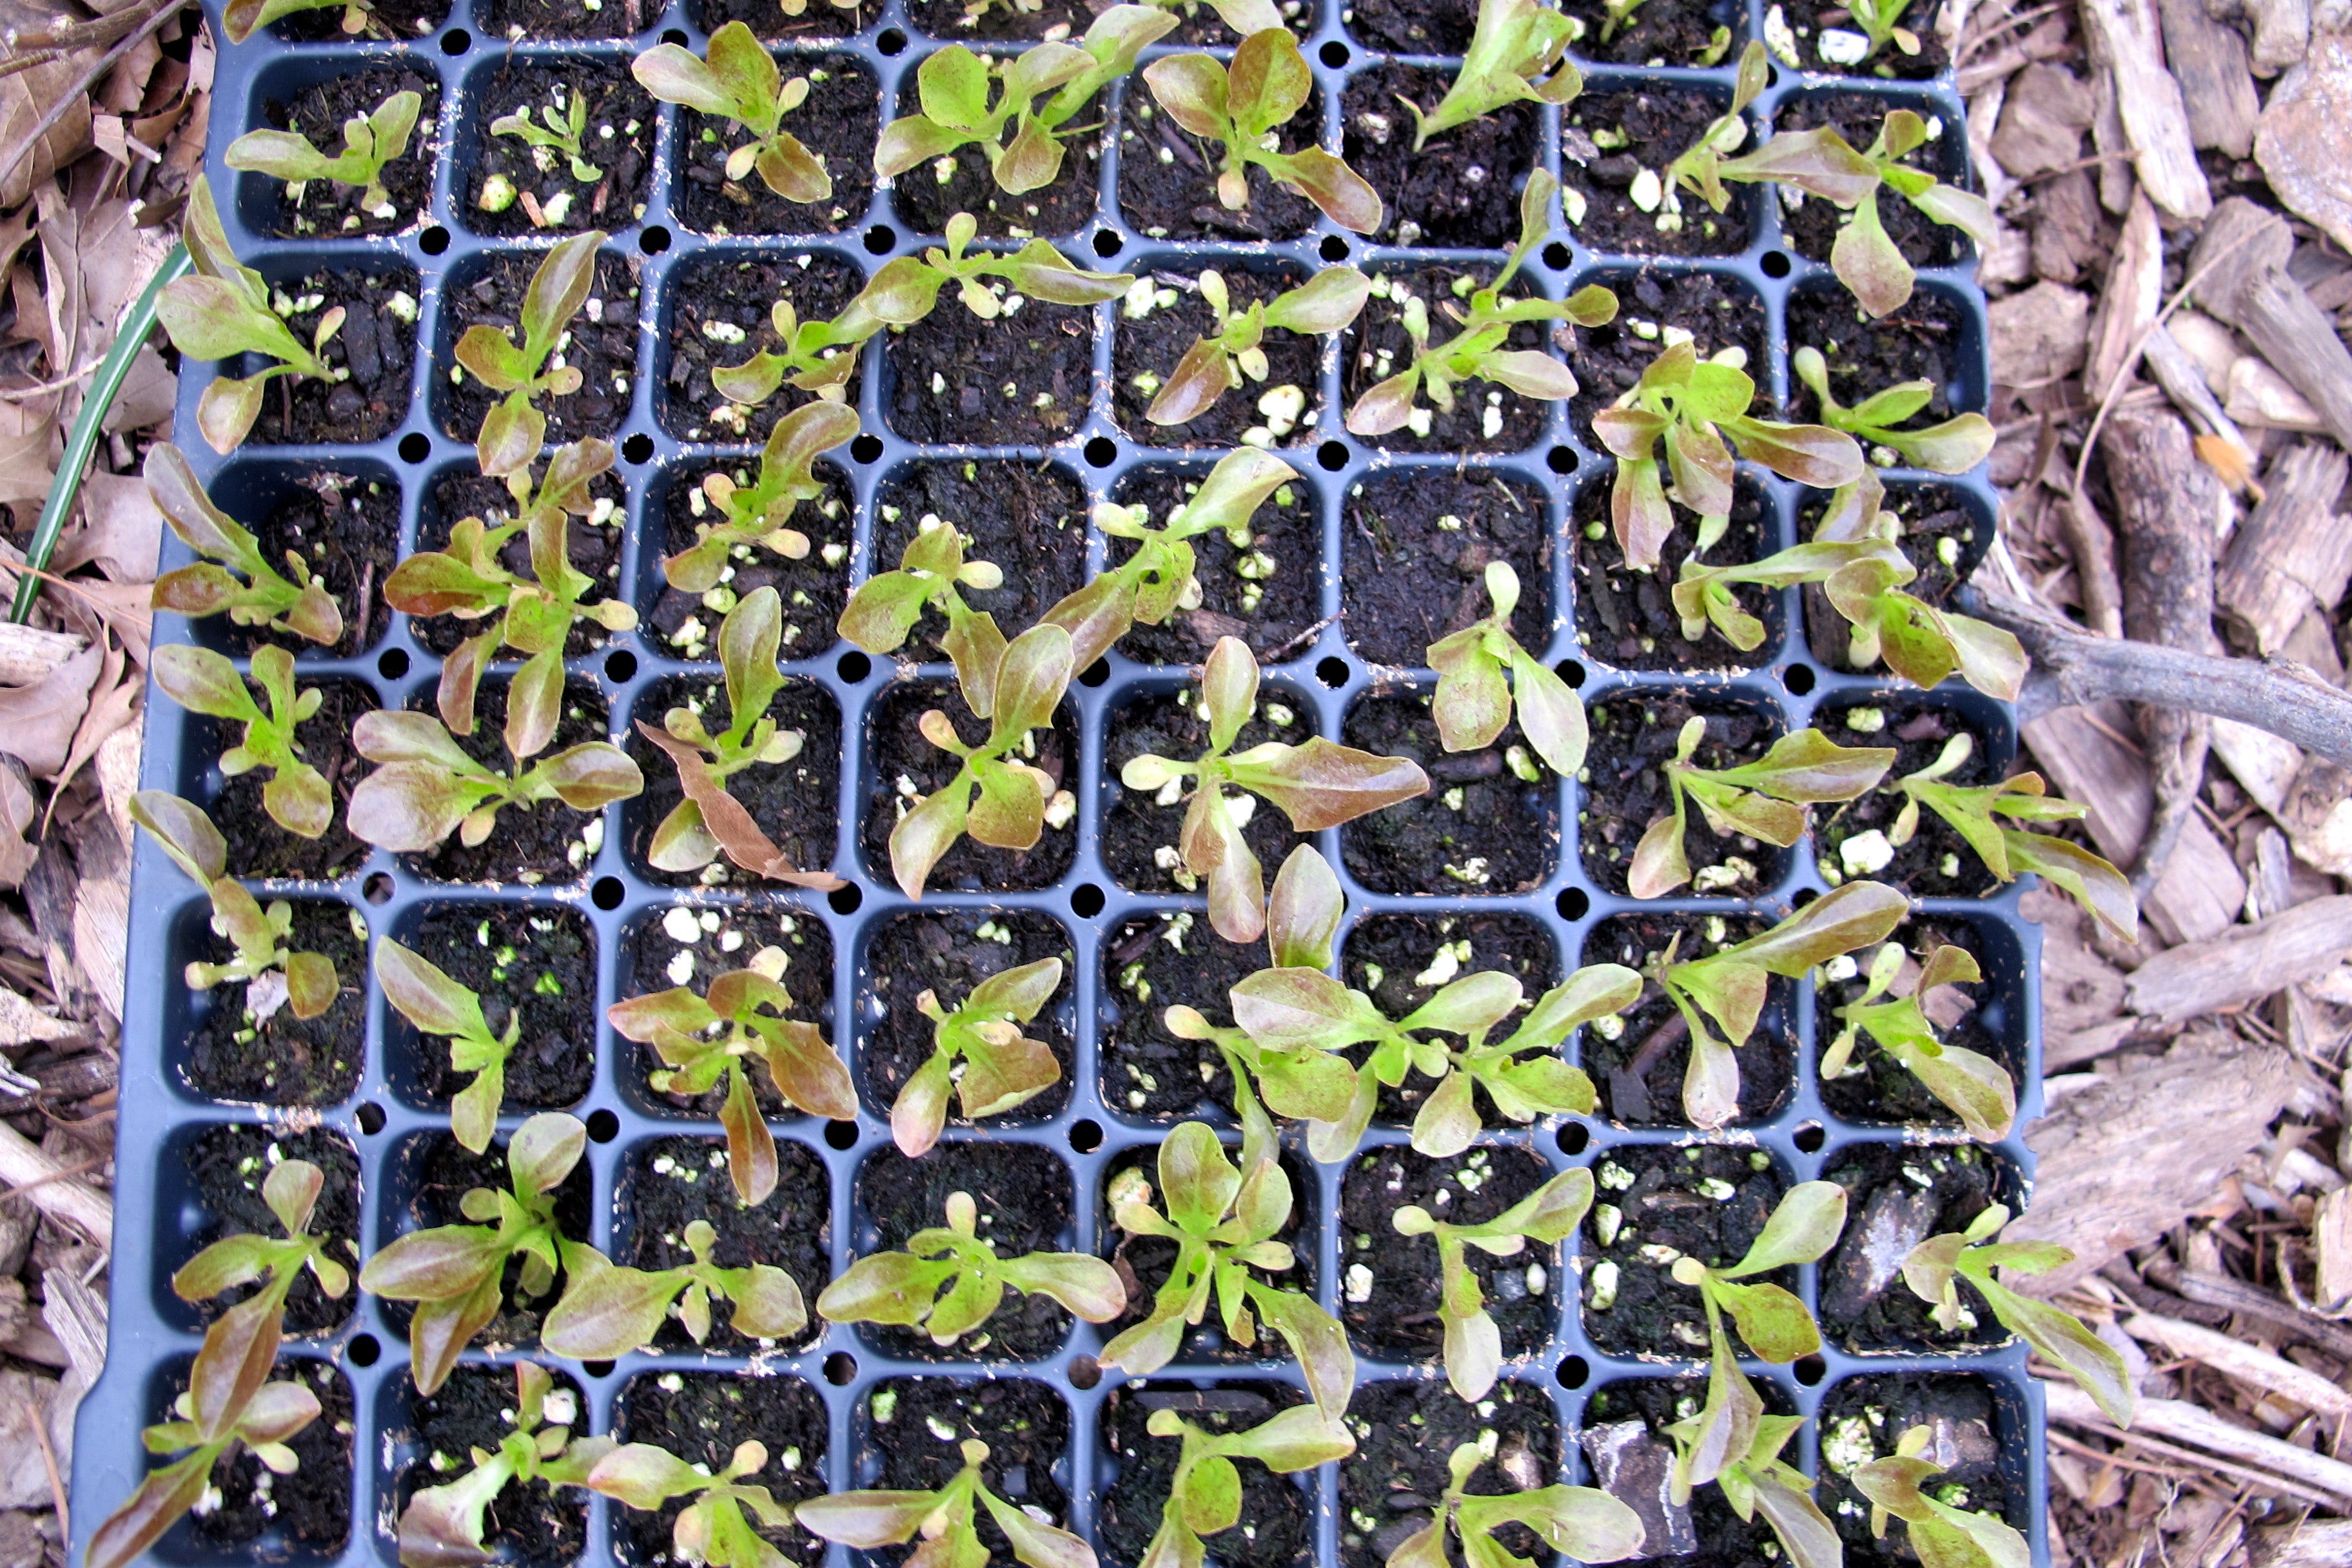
[1338,1145,1560,1361]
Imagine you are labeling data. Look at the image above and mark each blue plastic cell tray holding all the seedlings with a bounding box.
[73,0,2046,1568]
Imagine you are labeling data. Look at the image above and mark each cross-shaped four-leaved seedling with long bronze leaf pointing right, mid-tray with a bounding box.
[1119,637,1430,943]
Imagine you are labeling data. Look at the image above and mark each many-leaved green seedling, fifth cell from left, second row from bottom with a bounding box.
[1101,1121,1355,1422]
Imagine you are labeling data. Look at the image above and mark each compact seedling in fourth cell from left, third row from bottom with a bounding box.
[884,959,1061,1159]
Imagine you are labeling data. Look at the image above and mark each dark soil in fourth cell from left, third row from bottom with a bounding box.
[856,910,1077,1135]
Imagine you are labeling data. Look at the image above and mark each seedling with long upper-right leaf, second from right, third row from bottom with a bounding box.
[1651,881,1910,1131]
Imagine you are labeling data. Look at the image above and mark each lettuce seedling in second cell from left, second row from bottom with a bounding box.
[360,1112,588,1394]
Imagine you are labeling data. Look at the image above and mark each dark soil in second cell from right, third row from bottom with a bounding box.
[1583,914,1797,1126]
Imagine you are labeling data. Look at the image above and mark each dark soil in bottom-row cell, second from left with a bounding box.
[398,1366,588,1563]
